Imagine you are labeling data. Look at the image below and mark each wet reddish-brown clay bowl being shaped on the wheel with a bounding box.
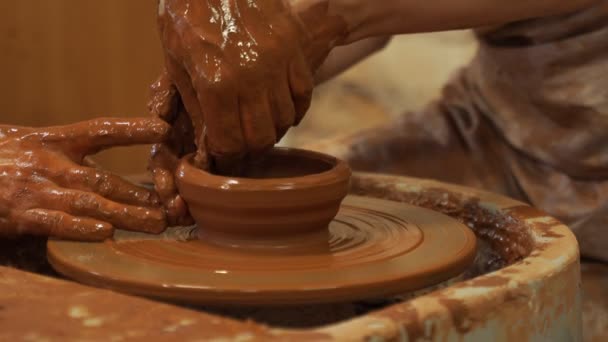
[177,148,351,238]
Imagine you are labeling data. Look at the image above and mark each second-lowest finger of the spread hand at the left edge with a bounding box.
[36,187,166,233]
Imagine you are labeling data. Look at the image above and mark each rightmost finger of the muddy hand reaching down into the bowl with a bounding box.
[289,54,314,125]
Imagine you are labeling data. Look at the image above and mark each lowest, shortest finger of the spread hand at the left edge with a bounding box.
[13,209,114,241]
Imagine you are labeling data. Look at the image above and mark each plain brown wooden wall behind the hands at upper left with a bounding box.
[0,0,162,173]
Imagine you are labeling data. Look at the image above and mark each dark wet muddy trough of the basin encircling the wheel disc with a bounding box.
[0,182,532,327]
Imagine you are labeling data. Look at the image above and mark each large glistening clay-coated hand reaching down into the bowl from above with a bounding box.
[159,0,346,161]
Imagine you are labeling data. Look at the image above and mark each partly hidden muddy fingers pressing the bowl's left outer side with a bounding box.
[148,71,195,226]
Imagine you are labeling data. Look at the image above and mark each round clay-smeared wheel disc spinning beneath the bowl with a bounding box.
[48,196,476,305]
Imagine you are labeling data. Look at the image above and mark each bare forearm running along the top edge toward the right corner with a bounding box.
[291,0,597,44]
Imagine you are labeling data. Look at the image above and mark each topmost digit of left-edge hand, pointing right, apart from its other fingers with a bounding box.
[39,118,170,156]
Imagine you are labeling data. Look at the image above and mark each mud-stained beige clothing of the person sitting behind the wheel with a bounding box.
[332,1,608,262]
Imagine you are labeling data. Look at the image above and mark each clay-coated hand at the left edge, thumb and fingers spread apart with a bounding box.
[0,119,169,241]
